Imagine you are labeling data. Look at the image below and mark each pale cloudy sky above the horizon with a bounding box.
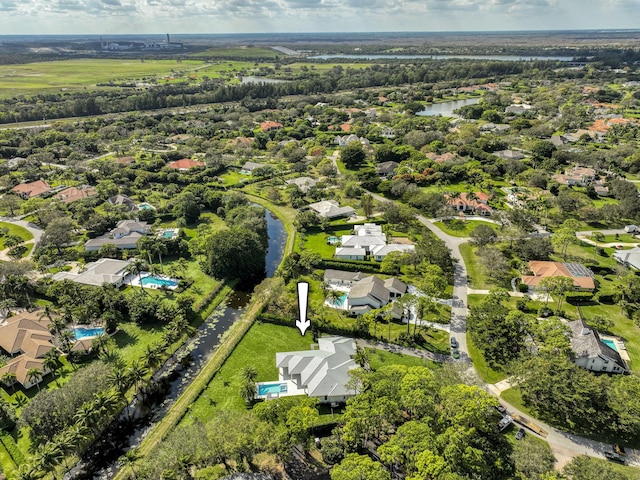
[0,0,640,35]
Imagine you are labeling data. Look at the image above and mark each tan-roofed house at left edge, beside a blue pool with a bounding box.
[0,311,56,388]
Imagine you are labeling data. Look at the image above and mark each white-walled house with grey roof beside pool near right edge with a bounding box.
[568,320,629,373]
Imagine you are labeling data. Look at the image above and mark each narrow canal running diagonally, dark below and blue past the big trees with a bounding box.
[74,210,287,480]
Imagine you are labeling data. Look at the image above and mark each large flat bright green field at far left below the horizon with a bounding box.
[0,58,202,98]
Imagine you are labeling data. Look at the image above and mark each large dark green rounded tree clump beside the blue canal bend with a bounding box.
[205,228,266,282]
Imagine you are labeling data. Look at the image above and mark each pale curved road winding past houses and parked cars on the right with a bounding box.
[372,193,640,468]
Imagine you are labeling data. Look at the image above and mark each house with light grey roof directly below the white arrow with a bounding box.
[276,337,357,403]
